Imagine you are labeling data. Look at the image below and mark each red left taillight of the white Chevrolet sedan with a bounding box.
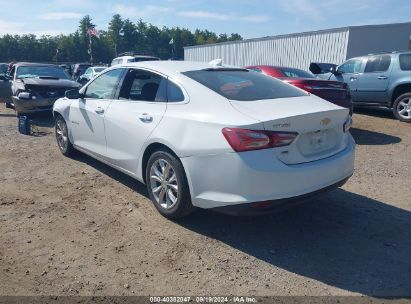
[222,128,298,152]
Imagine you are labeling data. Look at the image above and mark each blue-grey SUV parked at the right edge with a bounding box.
[310,51,411,122]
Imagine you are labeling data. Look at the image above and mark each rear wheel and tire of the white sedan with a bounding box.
[146,150,195,219]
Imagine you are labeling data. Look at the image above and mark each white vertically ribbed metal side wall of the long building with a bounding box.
[184,28,348,70]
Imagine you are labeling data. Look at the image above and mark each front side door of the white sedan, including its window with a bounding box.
[69,69,124,157]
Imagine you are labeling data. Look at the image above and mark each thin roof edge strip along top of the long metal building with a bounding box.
[184,22,411,49]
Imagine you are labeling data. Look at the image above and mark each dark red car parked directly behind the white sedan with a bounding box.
[245,65,353,115]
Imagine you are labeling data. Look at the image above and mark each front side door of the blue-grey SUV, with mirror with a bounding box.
[330,58,363,100]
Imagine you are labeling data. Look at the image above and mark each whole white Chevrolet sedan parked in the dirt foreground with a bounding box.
[54,61,355,218]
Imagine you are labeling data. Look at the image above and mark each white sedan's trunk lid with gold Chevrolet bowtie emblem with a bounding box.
[230,96,348,164]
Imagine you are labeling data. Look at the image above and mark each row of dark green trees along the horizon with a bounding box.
[0,14,243,63]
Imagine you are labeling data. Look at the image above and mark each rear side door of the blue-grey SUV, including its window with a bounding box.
[357,54,392,103]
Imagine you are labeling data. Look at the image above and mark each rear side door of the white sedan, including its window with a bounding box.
[105,68,167,174]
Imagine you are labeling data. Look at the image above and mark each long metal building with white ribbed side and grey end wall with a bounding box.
[184,22,411,70]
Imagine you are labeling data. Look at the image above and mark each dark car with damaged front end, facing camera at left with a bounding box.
[0,62,79,116]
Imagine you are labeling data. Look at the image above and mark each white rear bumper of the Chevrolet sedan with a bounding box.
[181,136,355,208]
